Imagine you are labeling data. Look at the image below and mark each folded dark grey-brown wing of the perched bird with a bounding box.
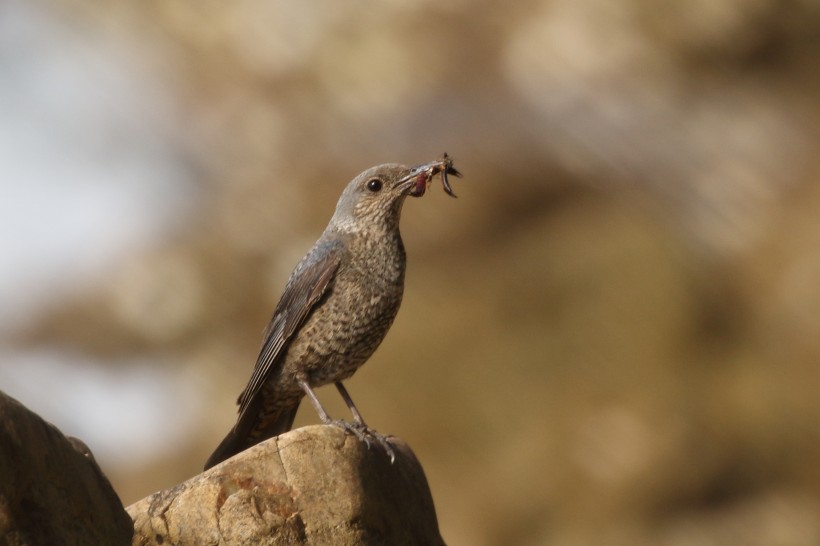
[237,240,342,421]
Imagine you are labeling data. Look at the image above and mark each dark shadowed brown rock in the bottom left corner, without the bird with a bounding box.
[0,392,133,546]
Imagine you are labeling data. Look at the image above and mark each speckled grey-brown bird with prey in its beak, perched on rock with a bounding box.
[205,154,460,470]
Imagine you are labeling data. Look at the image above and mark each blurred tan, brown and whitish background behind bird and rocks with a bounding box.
[0,0,820,546]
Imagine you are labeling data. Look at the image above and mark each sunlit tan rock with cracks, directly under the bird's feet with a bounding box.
[127,425,444,546]
